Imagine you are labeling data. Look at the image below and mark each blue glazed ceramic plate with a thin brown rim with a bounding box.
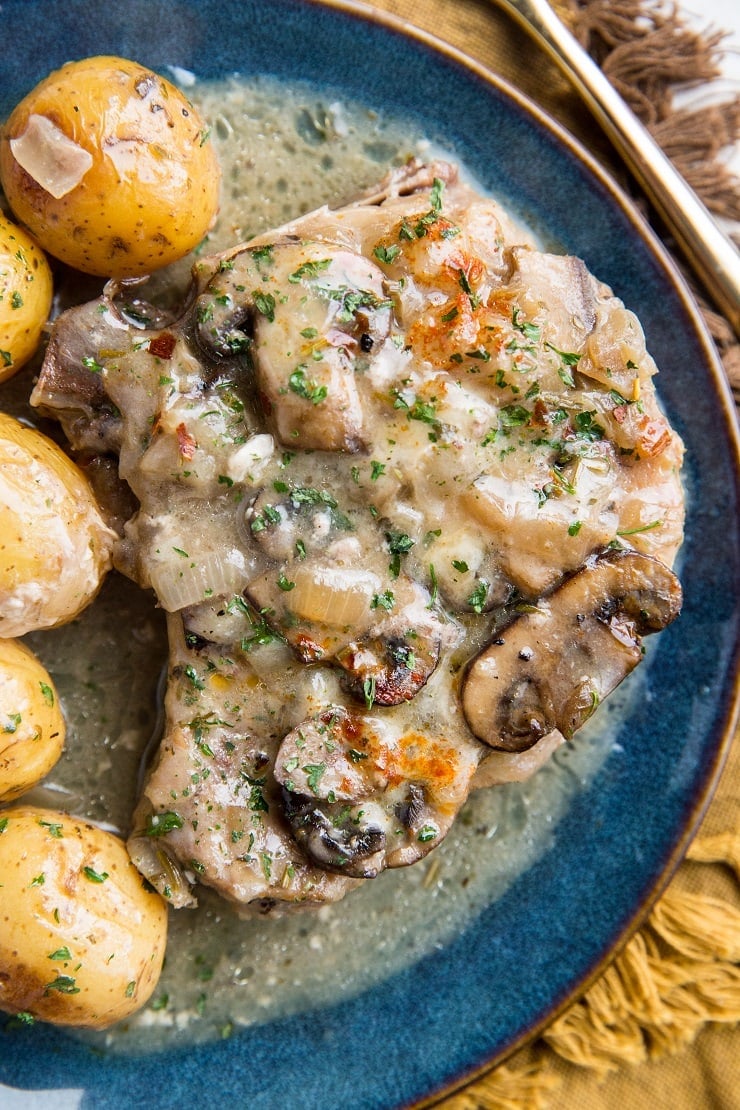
[0,0,740,1110]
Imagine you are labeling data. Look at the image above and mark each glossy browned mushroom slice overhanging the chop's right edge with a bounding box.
[463,551,681,751]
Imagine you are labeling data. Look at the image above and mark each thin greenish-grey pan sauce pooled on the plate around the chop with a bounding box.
[13,81,649,1052]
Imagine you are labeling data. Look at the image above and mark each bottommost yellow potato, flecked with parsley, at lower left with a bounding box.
[0,806,168,1029]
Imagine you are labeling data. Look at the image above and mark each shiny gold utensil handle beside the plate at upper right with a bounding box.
[496,0,740,337]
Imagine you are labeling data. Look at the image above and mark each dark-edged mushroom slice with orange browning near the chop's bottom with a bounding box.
[275,706,478,878]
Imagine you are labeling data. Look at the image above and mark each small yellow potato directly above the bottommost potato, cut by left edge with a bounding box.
[0,639,64,803]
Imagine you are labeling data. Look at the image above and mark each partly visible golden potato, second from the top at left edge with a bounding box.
[0,213,52,382]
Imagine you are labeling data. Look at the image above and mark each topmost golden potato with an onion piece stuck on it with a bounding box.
[0,57,221,278]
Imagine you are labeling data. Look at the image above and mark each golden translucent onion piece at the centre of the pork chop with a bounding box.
[287,565,381,630]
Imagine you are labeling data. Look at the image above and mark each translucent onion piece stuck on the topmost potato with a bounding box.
[10,114,92,200]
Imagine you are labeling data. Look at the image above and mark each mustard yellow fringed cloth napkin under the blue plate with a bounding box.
[355,0,740,1110]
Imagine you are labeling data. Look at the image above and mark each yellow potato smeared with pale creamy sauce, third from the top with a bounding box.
[0,413,115,638]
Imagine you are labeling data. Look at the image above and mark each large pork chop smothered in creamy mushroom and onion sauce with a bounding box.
[32,162,683,909]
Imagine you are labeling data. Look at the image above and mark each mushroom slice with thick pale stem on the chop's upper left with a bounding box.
[194,236,391,452]
